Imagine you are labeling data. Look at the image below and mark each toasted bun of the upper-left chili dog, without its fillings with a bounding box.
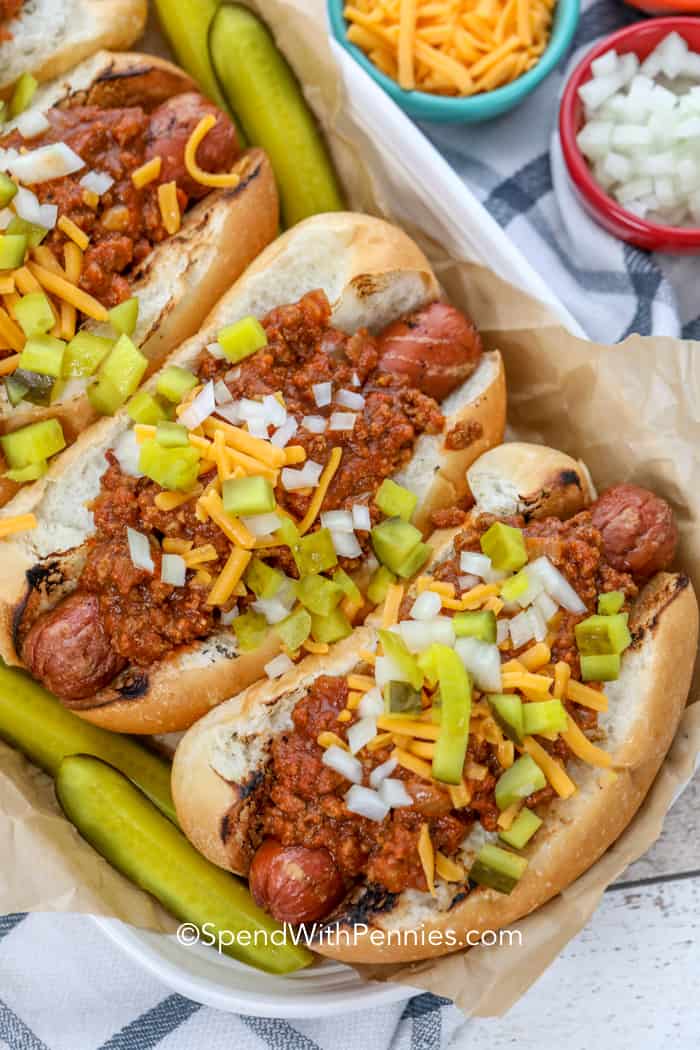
[0,51,278,505]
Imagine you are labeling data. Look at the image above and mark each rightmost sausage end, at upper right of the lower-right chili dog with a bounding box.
[591,485,678,580]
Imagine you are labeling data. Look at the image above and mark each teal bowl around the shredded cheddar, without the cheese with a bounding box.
[327,0,580,124]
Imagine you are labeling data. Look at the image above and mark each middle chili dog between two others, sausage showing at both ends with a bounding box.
[0,213,505,733]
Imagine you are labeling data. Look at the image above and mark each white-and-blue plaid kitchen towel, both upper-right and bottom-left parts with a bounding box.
[0,0,700,1050]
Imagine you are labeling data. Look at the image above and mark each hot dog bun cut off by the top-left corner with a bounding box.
[0,0,148,98]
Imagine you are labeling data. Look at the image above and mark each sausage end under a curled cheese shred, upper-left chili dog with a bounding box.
[146,91,239,200]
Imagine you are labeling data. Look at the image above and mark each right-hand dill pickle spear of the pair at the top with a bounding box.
[210,4,344,227]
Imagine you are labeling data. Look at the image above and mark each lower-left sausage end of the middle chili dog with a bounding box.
[22,593,126,707]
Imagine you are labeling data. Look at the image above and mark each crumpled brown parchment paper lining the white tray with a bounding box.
[0,0,700,1016]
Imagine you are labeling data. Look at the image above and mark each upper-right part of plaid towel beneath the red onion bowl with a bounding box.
[422,0,700,342]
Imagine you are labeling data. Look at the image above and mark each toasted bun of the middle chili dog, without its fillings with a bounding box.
[0,213,505,733]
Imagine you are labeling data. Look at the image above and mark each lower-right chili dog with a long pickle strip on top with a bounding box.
[173,444,698,963]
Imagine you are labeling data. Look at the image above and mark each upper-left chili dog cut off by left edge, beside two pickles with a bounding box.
[0,53,278,502]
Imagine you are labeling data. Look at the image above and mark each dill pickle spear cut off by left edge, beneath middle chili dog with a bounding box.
[0,667,177,823]
